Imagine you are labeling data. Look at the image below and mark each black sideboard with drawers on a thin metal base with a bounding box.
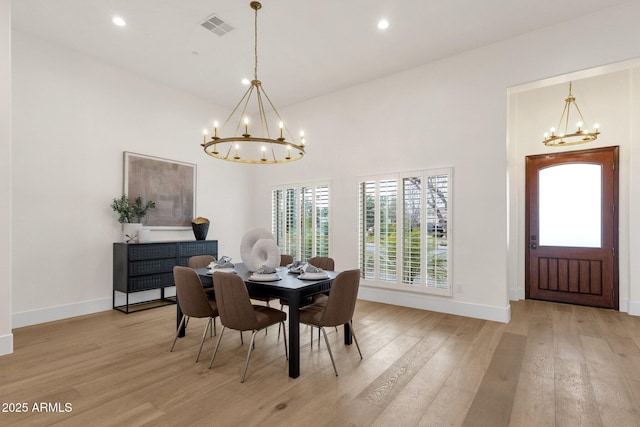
[113,240,218,314]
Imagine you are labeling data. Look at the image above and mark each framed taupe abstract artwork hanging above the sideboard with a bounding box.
[123,151,197,230]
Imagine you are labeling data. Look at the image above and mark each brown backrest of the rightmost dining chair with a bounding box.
[320,268,360,326]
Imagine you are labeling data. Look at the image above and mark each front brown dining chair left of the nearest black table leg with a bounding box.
[209,271,289,383]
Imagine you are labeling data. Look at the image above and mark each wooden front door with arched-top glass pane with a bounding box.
[525,147,618,309]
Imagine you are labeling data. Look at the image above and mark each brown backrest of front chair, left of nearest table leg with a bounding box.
[213,271,258,331]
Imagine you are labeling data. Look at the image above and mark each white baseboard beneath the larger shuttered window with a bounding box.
[358,285,511,323]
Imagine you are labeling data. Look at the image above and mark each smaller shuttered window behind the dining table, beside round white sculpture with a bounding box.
[271,184,330,261]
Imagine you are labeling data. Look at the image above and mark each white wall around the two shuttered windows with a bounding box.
[248,2,640,321]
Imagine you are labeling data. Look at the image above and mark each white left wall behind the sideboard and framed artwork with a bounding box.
[12,32,248,327]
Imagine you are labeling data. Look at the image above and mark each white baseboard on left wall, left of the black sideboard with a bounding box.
[11,298,113,328]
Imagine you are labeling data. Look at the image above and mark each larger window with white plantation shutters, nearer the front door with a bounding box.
[359,168,452,296]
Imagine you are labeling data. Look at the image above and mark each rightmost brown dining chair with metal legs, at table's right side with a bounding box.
[300,269,362,377]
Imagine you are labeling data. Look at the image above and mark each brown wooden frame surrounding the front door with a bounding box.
[524,146,620,310]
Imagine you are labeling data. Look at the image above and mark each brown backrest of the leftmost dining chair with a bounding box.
[173,265,217,317]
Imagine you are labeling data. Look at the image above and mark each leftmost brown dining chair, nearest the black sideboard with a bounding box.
[169,265,218,362]
